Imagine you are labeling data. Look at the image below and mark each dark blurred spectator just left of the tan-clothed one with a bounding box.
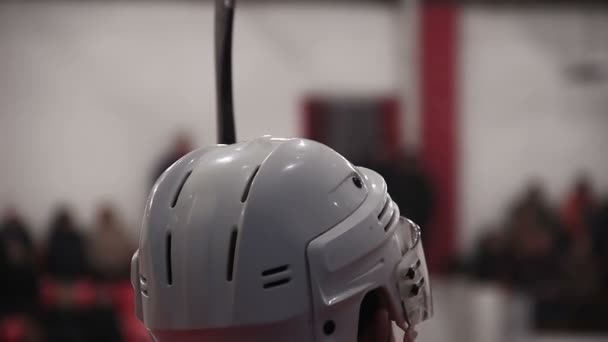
[46,208,88,281]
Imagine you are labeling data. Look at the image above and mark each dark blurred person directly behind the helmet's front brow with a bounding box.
[373,153,434,243]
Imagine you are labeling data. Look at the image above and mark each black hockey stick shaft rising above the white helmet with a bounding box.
[215,0,236,144]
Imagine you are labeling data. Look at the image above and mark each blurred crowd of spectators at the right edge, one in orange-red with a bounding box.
[467,176,608,331]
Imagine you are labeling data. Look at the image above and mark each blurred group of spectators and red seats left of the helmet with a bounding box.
[0,204,135,342]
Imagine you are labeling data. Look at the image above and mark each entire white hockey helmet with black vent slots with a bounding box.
[131,137,432,342]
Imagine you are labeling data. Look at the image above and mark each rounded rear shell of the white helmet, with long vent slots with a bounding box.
[132,137,368,340]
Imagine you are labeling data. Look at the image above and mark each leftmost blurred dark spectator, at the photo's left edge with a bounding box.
[0,208,38,316]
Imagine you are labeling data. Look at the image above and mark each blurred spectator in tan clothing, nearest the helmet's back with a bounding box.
[89,204,134,280]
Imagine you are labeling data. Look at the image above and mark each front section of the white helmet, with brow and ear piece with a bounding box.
[307,168,433,341]
